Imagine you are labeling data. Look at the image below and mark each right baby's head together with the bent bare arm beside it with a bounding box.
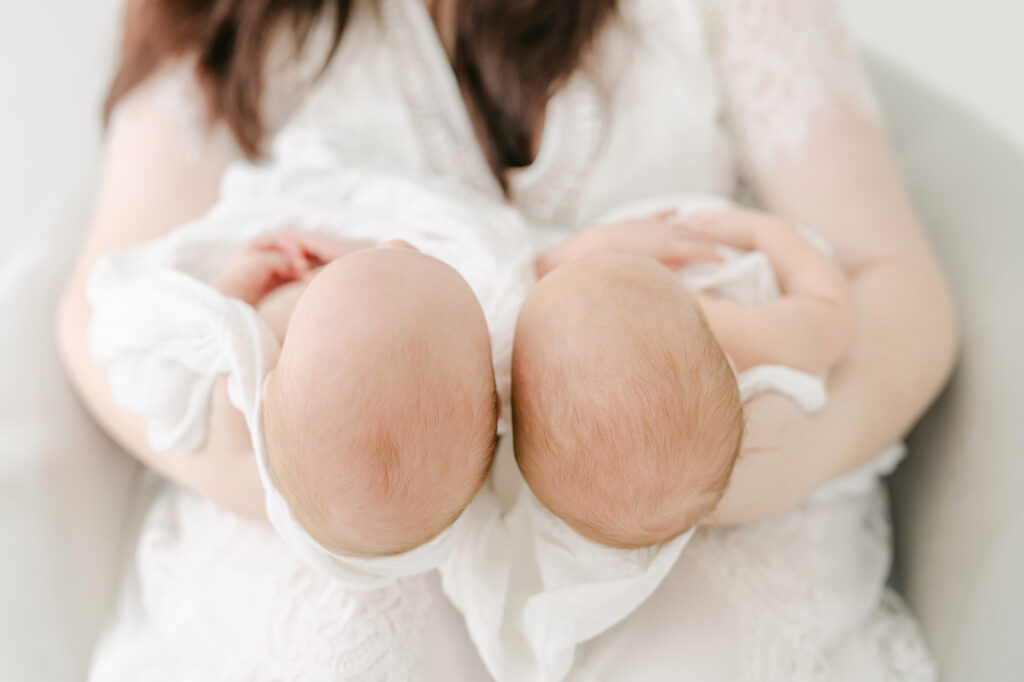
[512,206,852,548]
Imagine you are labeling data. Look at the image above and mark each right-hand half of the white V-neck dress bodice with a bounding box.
[520,0,735,226]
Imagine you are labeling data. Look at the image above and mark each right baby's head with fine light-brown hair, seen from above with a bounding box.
[512,254,743,548]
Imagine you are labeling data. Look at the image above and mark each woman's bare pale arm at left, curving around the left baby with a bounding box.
[56,65,263,517]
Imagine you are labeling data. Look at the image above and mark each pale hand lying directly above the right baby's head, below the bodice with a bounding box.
[537,210,722,278]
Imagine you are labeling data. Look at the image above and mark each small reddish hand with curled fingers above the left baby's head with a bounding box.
[211,232,372,305]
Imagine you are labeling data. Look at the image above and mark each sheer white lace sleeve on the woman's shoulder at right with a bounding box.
[706,0,880,174]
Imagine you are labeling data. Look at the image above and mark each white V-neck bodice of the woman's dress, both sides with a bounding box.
[285,0,735,228]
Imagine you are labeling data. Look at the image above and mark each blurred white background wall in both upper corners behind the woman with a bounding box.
[0,0,1024,251]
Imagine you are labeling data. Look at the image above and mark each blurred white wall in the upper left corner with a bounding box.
[0,0,121,249]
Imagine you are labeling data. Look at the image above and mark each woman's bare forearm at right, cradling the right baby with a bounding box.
[706,251,956,525]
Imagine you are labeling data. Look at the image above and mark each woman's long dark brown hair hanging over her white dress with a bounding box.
[105,0,616,184]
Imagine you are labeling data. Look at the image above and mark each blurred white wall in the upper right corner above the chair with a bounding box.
[839,0,1024,150]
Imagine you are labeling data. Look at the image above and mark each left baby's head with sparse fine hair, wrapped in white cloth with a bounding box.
[263,248,498,555]
